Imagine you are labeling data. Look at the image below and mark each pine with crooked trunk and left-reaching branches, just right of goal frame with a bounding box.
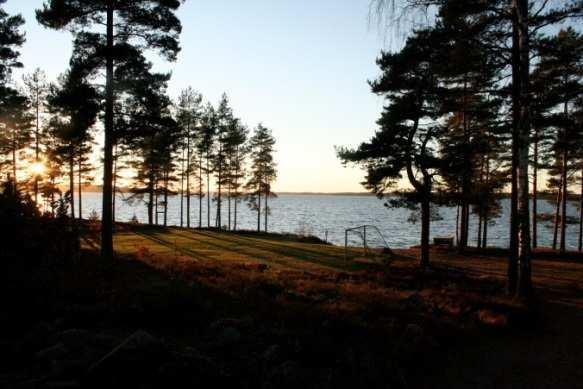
[338,30,440,267]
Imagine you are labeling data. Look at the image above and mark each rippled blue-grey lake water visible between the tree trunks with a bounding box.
[78,193,579,249]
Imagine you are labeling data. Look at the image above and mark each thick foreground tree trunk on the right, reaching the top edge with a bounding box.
[514,0,532,299]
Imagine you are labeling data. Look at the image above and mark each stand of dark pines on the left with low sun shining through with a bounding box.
[0,0,276,257]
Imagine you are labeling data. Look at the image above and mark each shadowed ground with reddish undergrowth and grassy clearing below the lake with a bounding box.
[0,225,583,388]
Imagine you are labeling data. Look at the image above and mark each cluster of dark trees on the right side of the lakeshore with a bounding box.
[338,0,583,297]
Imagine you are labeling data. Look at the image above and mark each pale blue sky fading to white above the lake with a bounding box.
[5,0,390,192]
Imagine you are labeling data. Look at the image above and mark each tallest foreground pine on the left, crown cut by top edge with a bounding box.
[37,0,181,258]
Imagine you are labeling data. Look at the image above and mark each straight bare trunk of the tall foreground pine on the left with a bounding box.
[101,3,114,259]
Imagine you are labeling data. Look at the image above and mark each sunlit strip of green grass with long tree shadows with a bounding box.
[104,225,388,271]
